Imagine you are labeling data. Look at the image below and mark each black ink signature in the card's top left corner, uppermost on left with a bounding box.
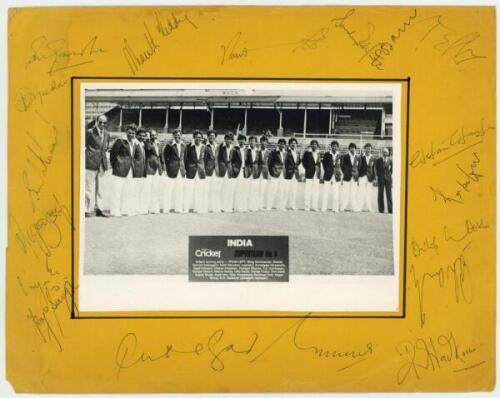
[26,36,108,76]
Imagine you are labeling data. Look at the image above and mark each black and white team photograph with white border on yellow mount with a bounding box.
[80,81,401,310]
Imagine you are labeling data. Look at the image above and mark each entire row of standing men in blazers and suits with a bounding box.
[85,117,392,217]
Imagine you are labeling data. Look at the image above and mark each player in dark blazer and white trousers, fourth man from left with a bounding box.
[144,130,163,214]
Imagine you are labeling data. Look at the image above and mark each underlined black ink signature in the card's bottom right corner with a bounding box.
[396,332,484,384]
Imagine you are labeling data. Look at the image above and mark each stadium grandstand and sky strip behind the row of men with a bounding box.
[85,89,393,153]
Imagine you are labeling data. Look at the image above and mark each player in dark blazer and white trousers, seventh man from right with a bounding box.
[266,138,286,210]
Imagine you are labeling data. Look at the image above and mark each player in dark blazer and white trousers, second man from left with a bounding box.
[109,124,137,217]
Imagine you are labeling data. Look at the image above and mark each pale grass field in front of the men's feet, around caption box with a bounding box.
[84,180,394,275]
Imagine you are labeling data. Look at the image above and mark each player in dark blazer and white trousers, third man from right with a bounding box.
[340,142,359,211]
